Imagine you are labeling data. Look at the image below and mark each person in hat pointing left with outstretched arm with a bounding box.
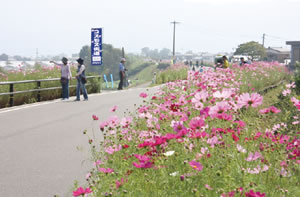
[50,57,72,101]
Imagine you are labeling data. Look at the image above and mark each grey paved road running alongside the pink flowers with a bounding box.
[0,88,157,197]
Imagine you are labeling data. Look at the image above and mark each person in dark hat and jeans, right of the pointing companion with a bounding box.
[75,58,88,101]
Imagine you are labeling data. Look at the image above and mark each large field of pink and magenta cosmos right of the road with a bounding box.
[73,62,300,197]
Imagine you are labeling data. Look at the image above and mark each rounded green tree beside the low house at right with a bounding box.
[234,41,266,59]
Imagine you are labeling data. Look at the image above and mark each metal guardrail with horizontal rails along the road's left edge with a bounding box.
[0,75,101,107]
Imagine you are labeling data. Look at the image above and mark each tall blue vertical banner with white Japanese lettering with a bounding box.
[91,28,102,66]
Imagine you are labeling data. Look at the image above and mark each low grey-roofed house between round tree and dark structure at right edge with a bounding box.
[267,47,291,63]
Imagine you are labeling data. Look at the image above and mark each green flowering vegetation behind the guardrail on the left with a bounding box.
[0,66,102,108]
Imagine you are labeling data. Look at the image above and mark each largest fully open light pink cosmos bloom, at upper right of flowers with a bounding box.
[237,93,263,108]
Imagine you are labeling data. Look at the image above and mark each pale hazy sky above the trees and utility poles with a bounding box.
[0,0,300,57]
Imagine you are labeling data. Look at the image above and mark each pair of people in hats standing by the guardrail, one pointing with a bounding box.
[50,57,88,101]
